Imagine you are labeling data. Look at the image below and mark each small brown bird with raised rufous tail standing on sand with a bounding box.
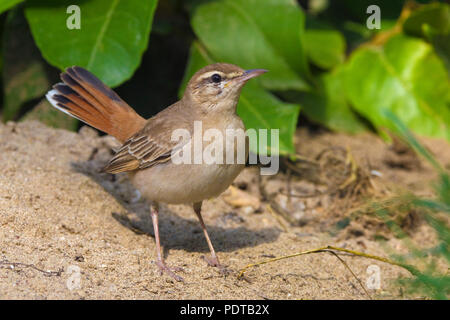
[46,63,267,281]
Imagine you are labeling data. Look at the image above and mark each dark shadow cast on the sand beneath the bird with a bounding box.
[72,159,281,256]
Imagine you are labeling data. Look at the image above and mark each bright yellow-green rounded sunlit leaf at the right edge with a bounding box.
[345,35,450,139]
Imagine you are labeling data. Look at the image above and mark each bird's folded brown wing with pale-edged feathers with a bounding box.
[102,105,191,173]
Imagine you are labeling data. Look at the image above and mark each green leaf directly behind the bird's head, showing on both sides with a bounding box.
[180,42,300,154]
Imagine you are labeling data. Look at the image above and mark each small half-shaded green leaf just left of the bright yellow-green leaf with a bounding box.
[286,66,365,133]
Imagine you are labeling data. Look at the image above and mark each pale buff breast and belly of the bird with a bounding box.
[131,116,248,204]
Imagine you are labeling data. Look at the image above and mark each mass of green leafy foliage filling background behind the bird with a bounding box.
[0,0,450,154]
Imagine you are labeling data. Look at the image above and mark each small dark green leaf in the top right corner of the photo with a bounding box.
[403,3,450,37]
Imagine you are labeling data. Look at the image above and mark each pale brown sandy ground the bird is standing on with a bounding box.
[0,122,450,299]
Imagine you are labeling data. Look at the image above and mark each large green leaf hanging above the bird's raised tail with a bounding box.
[26,0,157,87]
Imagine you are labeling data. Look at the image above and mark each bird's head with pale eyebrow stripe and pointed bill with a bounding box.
[184,63,267,112]
